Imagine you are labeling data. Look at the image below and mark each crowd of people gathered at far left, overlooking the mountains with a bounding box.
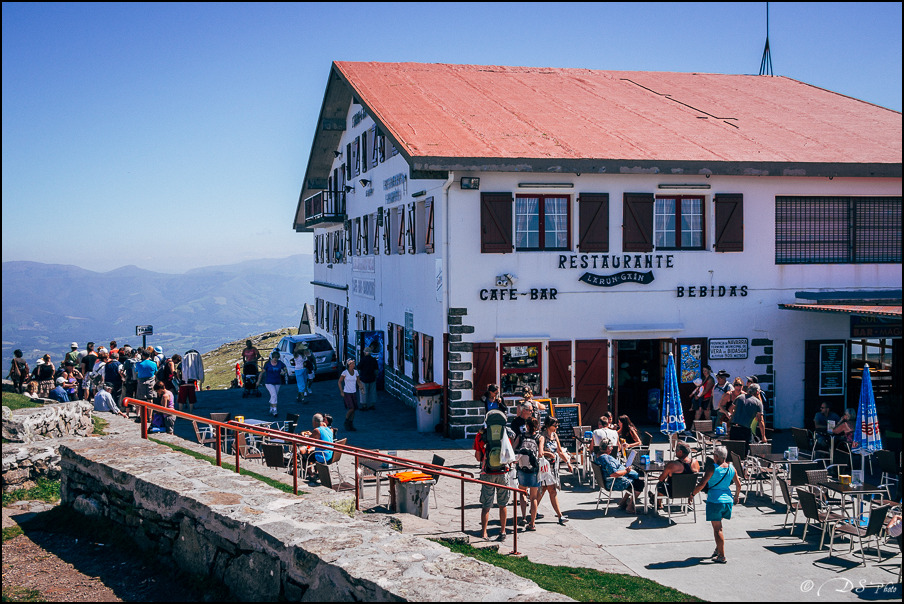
[9,340,182,433]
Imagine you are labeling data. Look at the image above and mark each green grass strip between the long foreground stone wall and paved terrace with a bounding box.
[437,540,704,602]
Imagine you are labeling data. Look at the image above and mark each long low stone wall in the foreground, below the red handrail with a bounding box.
[60,431,567,601]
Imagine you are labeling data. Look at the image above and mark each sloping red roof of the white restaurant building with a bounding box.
[335,62,902,168]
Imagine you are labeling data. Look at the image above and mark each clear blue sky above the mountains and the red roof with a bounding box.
[2,3,902,272]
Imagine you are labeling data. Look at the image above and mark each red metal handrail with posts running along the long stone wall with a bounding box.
[123,398,528,554]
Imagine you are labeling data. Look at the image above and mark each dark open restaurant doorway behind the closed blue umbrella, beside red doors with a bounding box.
[612,340,672,424]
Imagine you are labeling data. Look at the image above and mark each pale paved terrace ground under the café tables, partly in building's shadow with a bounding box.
[145,379,901,601]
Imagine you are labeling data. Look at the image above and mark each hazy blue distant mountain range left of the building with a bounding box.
[2,254,314,368]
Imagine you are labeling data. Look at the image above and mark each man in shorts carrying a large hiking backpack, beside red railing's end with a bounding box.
[474,409,514,542]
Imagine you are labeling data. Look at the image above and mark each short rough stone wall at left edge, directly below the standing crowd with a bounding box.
[3,401,94,443]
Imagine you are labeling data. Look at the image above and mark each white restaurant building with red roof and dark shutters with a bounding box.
[294,62,902,438]
